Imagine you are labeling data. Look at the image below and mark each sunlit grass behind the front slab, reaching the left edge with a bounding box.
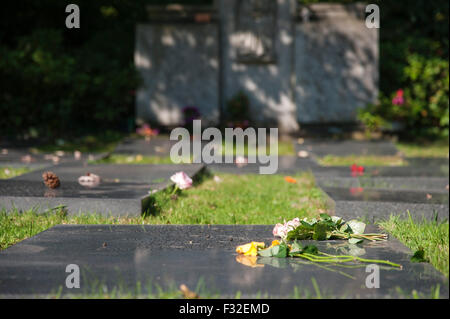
[0,173,327,249]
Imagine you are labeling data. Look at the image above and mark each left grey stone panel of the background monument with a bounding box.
[135,24,219,126]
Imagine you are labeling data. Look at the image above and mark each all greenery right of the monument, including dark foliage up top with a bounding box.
[359,0,449,138]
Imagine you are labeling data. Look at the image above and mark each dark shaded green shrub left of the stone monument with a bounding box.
[0,29,138,139]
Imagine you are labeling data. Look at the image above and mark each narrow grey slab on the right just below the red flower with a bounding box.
[316,176,449,192]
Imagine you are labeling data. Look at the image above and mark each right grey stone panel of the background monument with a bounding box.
[295,4,378,123]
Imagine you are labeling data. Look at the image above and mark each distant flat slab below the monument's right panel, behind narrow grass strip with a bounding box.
[295,139,399,157]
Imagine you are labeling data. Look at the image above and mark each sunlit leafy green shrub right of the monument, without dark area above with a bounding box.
[358,54,449,137]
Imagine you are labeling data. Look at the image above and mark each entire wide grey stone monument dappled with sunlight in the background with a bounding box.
[135,0,378,132]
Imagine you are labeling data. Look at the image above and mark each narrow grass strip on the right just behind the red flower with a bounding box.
[317,155,408,166]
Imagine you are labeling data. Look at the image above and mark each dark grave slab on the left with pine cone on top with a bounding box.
[0,164,204,215]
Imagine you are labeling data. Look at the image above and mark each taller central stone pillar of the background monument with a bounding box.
[220,0,298,131]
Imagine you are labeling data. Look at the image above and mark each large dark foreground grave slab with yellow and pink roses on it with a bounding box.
[0,225,448,298]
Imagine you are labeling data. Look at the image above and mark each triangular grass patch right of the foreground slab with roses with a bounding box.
[380,216,449,277]
